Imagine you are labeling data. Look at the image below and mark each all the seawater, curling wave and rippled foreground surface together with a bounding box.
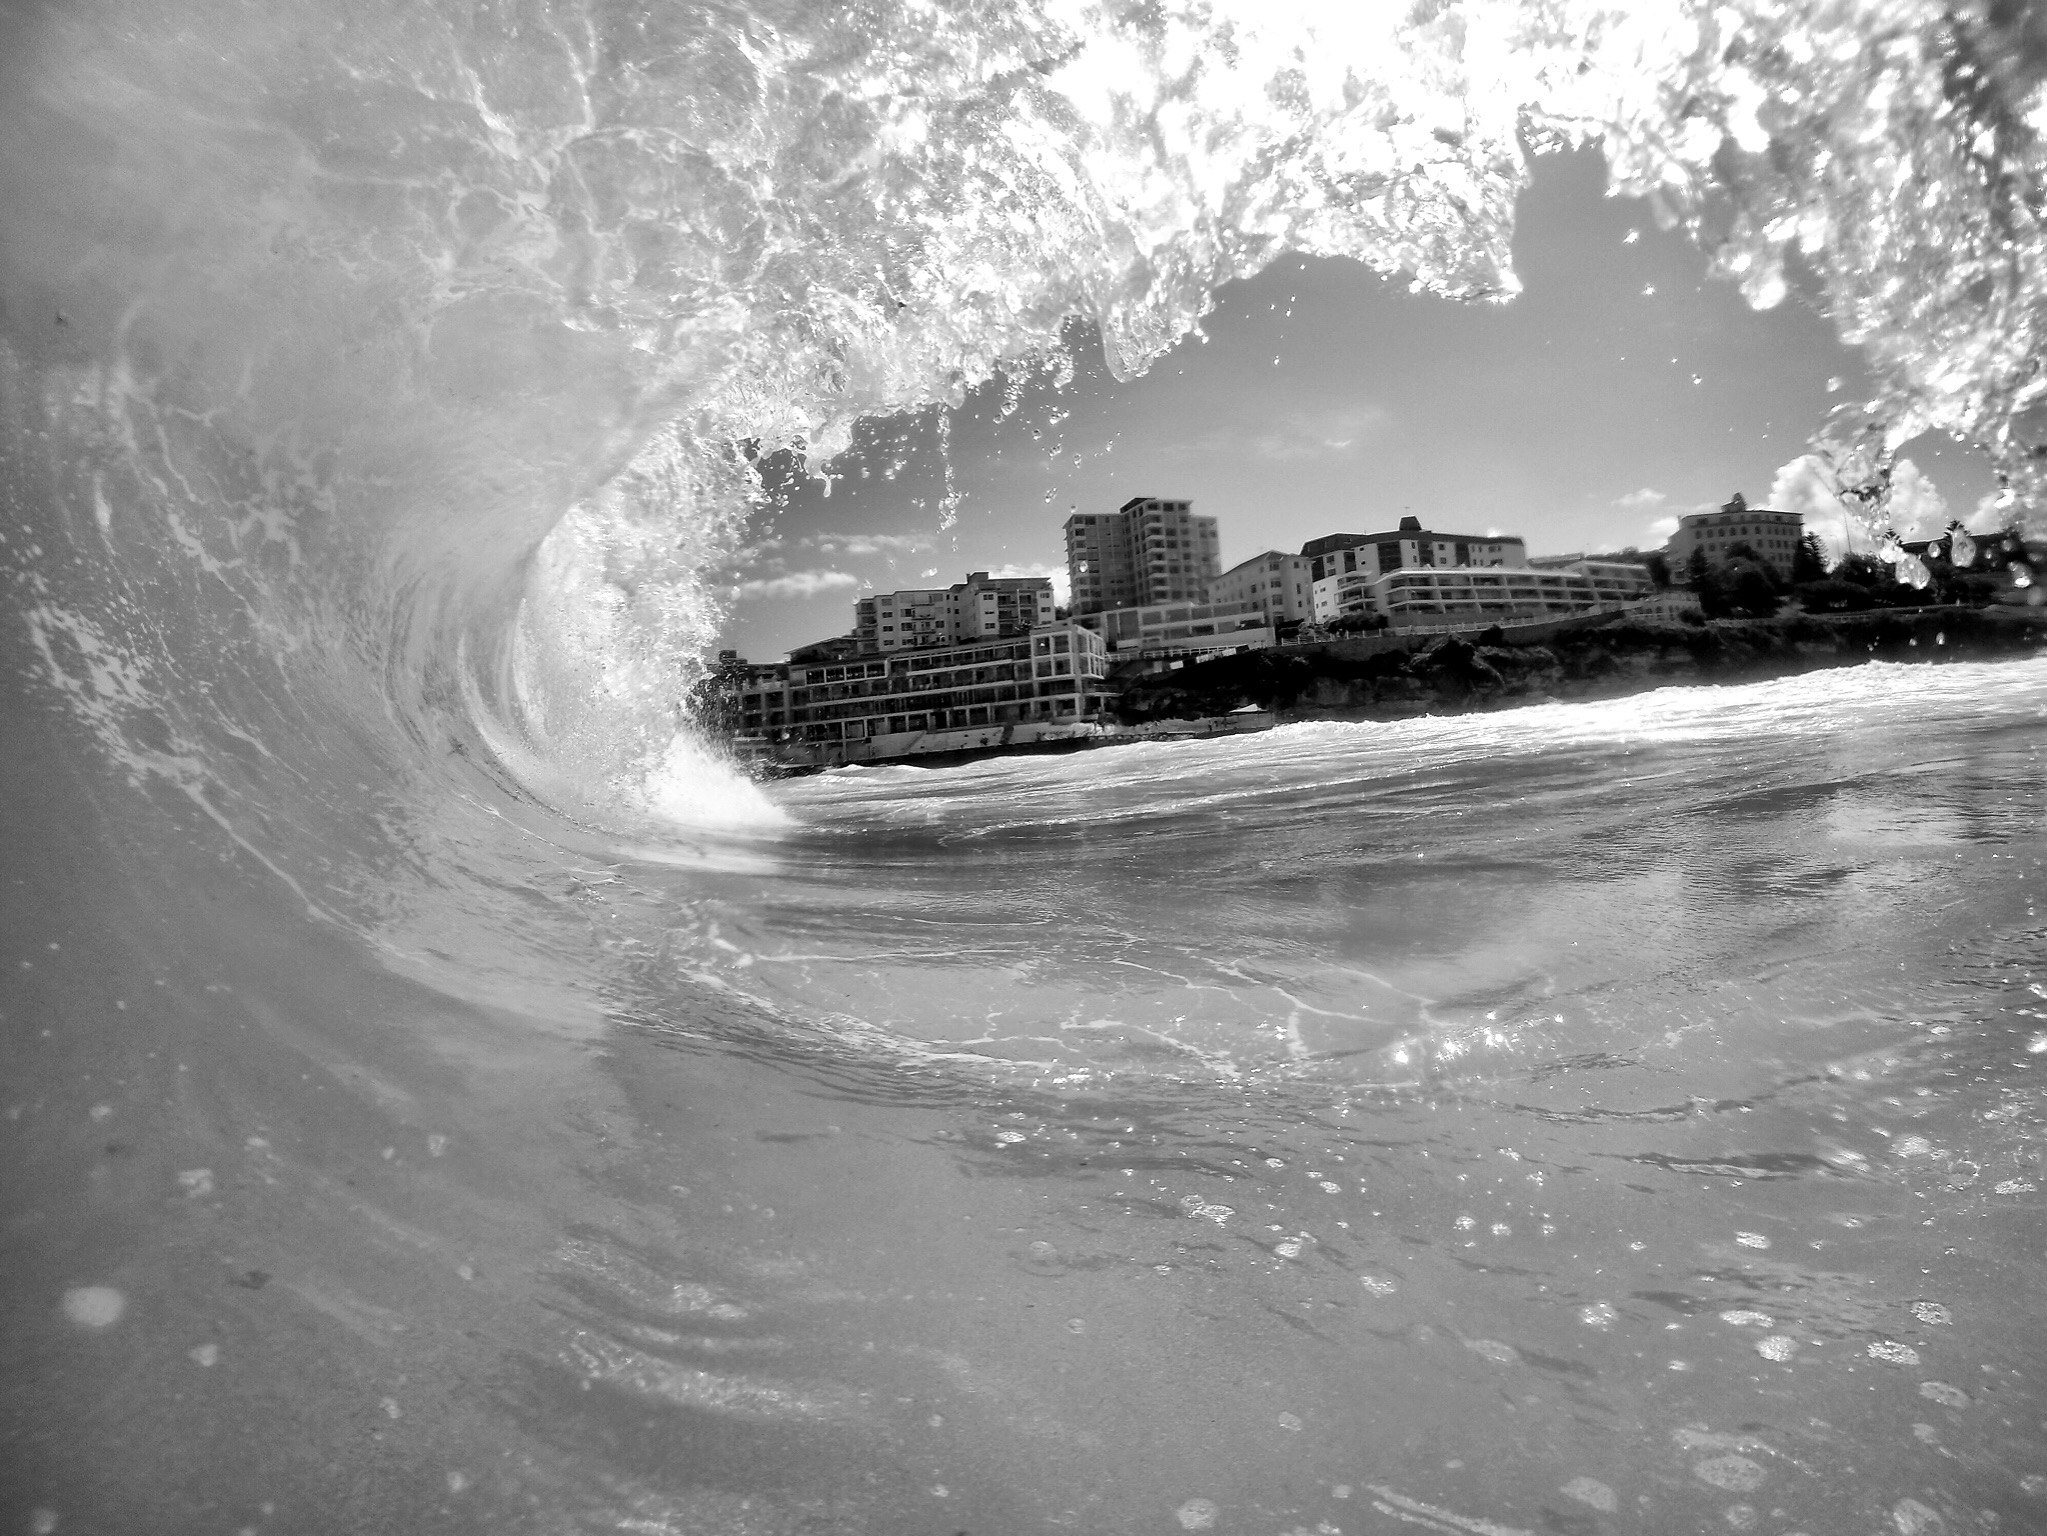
[0,0,2047,1536]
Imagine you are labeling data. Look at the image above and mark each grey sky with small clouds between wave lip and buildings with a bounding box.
[721,150,1994,659]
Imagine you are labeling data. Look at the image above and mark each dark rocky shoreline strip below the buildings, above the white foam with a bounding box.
[1118,606,2047,725]
